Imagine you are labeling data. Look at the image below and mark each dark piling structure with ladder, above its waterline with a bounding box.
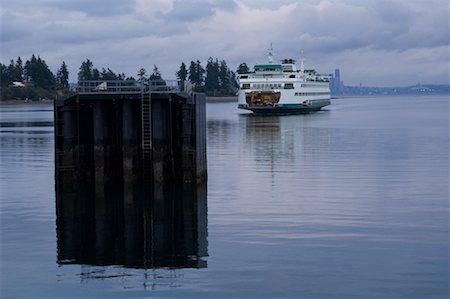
[54,92,207,189]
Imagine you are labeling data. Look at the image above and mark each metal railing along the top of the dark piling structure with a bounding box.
[77,79,183,94]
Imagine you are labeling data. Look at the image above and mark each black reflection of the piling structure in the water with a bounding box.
[56,183,208,269]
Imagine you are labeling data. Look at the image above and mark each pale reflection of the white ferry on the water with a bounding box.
[239,111,333,169]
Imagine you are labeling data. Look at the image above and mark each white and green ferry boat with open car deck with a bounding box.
[237,47,331,114]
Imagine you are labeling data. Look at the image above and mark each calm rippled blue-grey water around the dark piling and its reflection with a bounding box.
[0,96,450,298]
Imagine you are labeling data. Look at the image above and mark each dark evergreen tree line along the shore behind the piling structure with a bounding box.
[0,54,246,98]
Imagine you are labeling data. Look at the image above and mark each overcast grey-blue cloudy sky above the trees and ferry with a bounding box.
[0,0,450,86]
